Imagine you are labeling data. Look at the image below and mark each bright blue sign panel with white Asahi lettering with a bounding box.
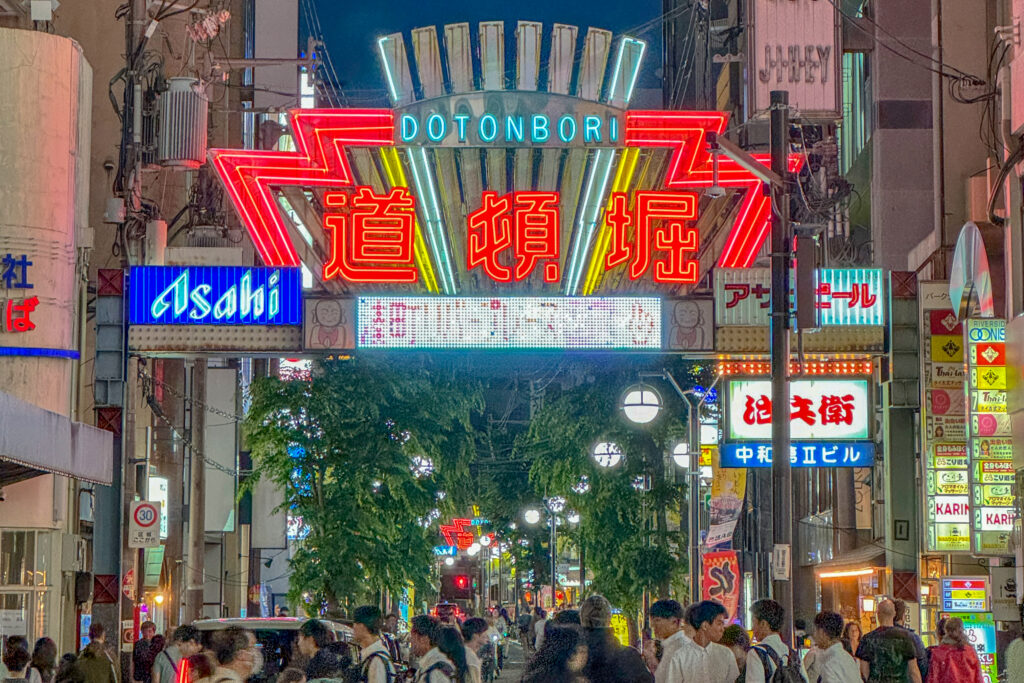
[128,265,302,325]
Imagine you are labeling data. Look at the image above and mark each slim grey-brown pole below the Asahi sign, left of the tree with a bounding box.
[183,358,207,624]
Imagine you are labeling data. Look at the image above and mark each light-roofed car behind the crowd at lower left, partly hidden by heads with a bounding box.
[196,616,353,683]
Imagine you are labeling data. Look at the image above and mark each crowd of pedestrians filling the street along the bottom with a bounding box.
[0,595,1024,683]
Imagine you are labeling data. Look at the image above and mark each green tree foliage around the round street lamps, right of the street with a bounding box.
[519,367,707,613]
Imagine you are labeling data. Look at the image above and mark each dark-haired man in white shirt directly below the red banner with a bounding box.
[657,600,739,683]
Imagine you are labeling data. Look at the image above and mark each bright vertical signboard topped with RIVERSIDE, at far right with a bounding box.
[965,318,1017,555]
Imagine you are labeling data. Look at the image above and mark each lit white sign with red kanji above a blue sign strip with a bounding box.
[726,379,870,441]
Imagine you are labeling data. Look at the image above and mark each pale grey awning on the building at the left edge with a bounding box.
[0,392,114,485]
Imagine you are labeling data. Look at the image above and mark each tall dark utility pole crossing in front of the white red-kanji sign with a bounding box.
[771,90,793,642]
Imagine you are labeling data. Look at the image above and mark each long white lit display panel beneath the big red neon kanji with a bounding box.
[355,296,662,351]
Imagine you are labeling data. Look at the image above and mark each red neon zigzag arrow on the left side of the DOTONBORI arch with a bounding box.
[209,110,394,266]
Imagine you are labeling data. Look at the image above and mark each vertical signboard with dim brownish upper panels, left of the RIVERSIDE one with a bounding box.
[918,282,971,553]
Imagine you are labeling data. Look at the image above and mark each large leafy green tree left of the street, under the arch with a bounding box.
[245,355,480,611]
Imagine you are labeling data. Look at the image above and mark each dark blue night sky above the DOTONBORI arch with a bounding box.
[300,0,662,98]
